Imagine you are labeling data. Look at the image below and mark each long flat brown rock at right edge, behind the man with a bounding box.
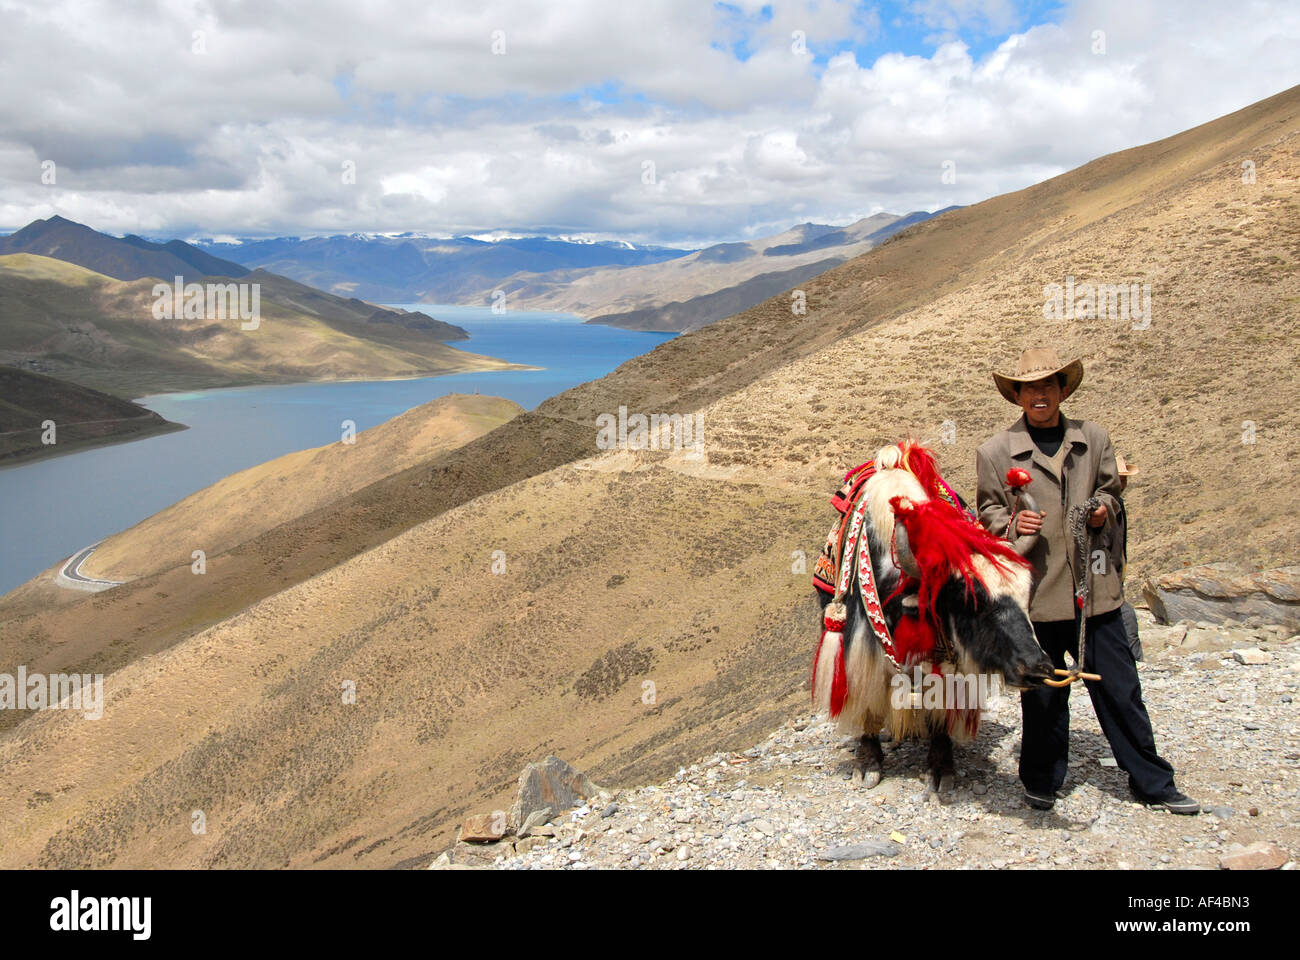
[1141,562,1300,630]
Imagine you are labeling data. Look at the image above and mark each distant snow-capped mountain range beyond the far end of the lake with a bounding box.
[188,208,950,332]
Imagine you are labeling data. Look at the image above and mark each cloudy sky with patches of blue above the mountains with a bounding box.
[0,0,1300,245]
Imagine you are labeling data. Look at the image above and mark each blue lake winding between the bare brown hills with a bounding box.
[0,303,676,594]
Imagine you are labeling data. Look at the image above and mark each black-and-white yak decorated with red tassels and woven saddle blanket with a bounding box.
[813,442,1053,792]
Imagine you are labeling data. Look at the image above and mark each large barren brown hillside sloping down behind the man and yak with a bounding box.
[0,88,1300,866]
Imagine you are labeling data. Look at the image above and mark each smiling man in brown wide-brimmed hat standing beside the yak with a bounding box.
[976,347,1200,813]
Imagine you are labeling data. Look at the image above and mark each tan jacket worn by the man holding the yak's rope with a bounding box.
[975,414,1125,622]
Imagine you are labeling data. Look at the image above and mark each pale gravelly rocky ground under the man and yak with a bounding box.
[434,610,1300,870]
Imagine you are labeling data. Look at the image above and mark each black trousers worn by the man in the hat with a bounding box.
[1021,609,1175,800]
